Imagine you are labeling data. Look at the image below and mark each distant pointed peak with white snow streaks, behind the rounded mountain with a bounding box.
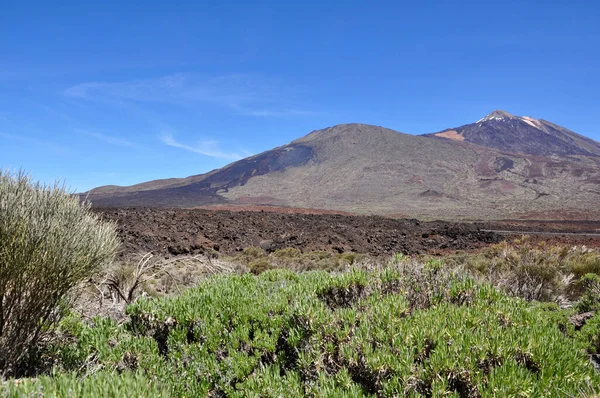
[428,110,600,156]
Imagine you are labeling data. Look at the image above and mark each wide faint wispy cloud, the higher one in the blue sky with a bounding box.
[64,73,314,117]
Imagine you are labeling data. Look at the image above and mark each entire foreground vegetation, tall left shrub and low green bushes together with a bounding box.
[0,173,600,398]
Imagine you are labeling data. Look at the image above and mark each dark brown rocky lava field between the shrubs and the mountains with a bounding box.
[99,208,501,256]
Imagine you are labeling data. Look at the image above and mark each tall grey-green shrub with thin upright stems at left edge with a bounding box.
[0,171,118,374]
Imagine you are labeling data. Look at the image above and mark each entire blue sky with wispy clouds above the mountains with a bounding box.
[0,0,600,191]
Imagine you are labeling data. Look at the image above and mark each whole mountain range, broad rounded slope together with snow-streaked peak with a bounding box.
[83,111,600,219]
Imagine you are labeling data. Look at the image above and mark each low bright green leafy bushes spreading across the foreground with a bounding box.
[4,260,600,397]
